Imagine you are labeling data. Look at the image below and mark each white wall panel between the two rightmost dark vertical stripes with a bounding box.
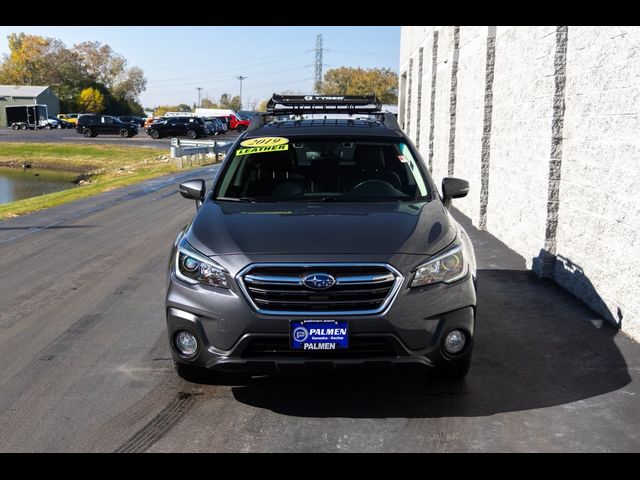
[488,27,555,267]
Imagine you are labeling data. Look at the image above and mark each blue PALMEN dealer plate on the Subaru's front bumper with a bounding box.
[289,320,349,352]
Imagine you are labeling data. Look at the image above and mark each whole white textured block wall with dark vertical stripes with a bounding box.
[400,26,640,340]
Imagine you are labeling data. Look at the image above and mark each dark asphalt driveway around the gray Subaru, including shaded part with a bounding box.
[0,171,640,452]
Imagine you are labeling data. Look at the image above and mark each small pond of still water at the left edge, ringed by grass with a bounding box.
[0,167,77,204]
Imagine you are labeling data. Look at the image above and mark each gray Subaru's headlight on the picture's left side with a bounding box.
[175,238,230,288]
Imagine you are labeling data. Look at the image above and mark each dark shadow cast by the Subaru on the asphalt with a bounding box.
[232,210,631,418]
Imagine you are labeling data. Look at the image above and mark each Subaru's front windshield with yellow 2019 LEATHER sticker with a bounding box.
[215,137,430,202]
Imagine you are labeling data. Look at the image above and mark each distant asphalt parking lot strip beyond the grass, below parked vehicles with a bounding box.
[0,128,238,151]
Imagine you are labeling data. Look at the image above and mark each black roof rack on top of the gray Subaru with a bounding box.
[247,93,401,131]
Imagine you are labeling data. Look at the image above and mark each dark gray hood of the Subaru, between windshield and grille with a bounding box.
[186,200,456,256]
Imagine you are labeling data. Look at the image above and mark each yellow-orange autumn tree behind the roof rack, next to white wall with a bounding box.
[319,67,398,103]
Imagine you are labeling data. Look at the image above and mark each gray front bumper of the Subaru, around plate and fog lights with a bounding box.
[166,272,476,372]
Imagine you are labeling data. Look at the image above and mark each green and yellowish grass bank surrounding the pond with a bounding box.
[0,143,185,220]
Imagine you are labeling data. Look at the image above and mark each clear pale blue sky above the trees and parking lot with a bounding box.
[0,26,400,108]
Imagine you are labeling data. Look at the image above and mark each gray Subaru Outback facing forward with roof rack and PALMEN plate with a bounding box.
[166,94,476,382]
